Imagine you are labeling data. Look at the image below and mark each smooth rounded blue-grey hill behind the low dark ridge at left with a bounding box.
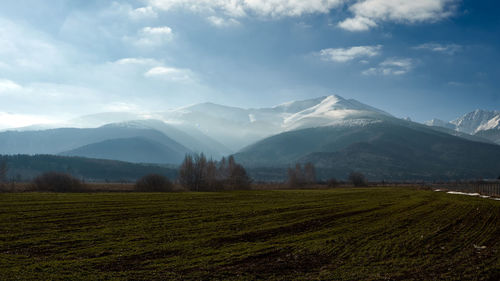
[60,137,184,164]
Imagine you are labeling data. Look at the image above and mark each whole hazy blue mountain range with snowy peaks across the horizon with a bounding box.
[0,96,500,179]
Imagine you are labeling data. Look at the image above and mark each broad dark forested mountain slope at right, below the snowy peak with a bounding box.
[235,120,500,179]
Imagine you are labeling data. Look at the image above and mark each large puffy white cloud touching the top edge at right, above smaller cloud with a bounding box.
[338,0,458,31]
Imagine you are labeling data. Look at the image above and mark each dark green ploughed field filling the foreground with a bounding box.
[0,188,500,280]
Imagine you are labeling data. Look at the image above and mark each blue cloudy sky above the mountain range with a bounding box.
[0,0,500,128]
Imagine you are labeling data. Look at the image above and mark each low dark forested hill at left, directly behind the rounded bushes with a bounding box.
[0,155,177,182]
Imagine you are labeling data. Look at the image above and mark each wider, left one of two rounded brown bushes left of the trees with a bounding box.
[33,172,84,192]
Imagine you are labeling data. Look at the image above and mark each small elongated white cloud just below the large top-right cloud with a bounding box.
[319,45,382,62]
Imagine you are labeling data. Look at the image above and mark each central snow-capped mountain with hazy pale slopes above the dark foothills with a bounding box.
[155,95,390,151]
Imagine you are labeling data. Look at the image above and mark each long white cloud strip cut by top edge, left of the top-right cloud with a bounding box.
[149,0,344,17]
